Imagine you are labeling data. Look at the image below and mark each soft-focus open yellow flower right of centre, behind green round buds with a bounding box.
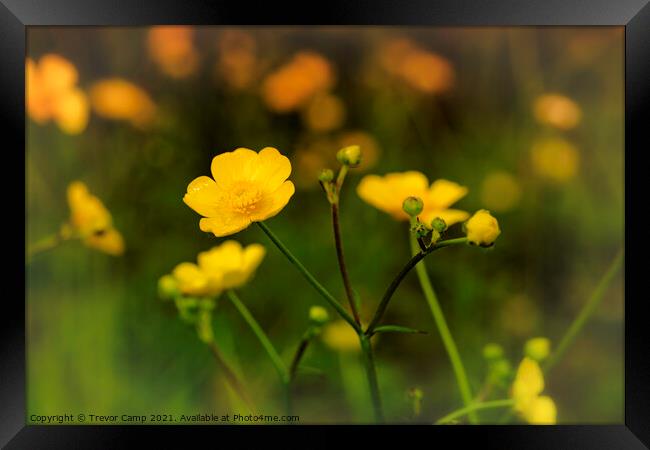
[357,171,469,226]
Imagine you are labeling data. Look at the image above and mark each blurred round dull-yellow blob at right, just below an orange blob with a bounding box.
[530,137,580,182]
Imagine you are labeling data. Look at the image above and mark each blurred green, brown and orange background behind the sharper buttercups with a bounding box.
[26,27,624,423]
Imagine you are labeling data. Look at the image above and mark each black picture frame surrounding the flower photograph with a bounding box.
[5,0,650,450]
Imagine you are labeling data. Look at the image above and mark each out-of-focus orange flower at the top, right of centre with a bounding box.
[380,38,454,94]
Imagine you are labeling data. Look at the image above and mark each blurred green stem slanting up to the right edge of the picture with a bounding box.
[543,249,624,373]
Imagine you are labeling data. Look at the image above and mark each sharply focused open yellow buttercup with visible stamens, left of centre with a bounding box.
[183,147,295,237]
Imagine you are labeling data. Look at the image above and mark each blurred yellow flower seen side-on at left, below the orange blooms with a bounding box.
[67,181,124,255]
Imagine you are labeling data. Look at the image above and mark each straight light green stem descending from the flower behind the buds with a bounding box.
[410,236,478,423]
